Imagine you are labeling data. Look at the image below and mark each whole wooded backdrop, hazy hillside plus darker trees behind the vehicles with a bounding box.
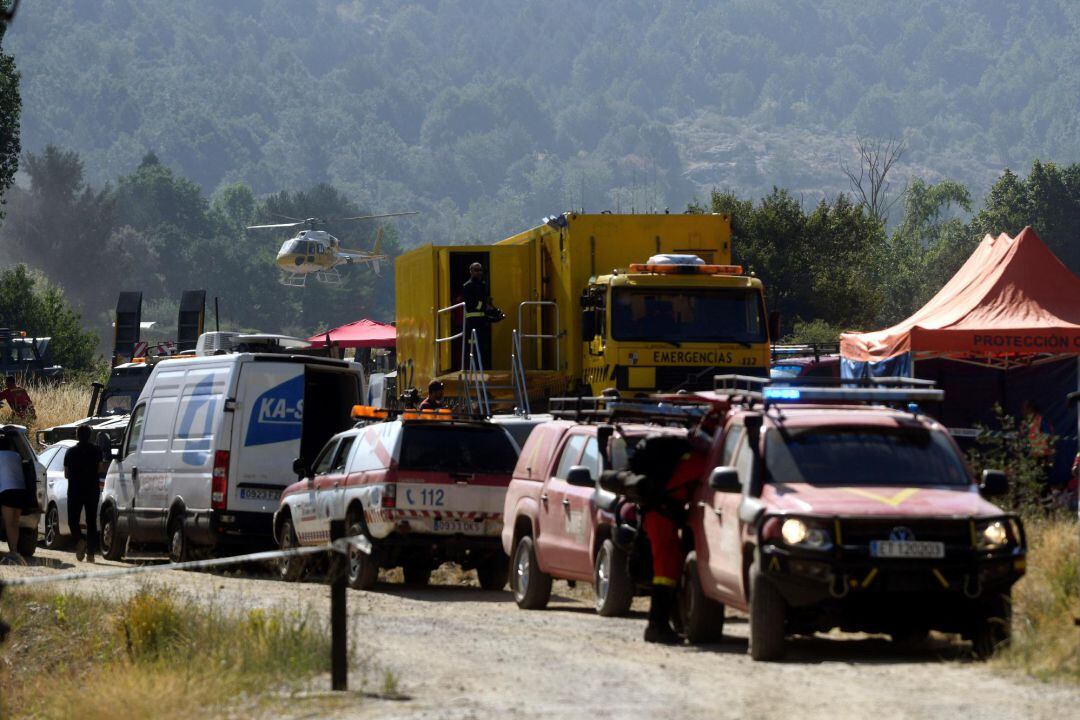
[0,0,1080,360]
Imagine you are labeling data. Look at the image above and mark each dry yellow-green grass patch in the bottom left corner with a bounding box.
[0,587,329,720]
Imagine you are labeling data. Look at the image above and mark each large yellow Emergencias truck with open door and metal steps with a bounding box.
[395,213,769,408]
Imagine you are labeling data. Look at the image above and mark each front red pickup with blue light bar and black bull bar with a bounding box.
[679,388,1025,660]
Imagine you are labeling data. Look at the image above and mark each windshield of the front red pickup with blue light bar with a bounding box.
[765,426,970,486]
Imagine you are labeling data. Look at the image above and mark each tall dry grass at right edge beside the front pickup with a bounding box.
[995,517,1080,682]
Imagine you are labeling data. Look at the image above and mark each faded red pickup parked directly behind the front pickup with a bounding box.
[502,420,686,616]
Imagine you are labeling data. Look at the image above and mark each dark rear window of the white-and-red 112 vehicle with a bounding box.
[397,423,517,475]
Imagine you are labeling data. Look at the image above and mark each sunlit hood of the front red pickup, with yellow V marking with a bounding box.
[761,483,1001,517]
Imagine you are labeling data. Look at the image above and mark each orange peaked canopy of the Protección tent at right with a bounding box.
[840,228,1080,363]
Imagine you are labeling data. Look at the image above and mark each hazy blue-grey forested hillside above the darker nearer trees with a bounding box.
[8,0,1080,243]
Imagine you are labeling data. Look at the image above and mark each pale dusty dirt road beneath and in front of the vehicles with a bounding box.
[0,551,1080,720]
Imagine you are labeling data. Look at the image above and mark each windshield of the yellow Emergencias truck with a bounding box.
[611,288,765,343]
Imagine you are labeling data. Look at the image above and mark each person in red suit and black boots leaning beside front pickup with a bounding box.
[643,432,708,644]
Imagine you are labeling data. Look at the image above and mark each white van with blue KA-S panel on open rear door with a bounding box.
[99,353,364,561]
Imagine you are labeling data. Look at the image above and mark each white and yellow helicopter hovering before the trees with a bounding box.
[247,212,416,287]
